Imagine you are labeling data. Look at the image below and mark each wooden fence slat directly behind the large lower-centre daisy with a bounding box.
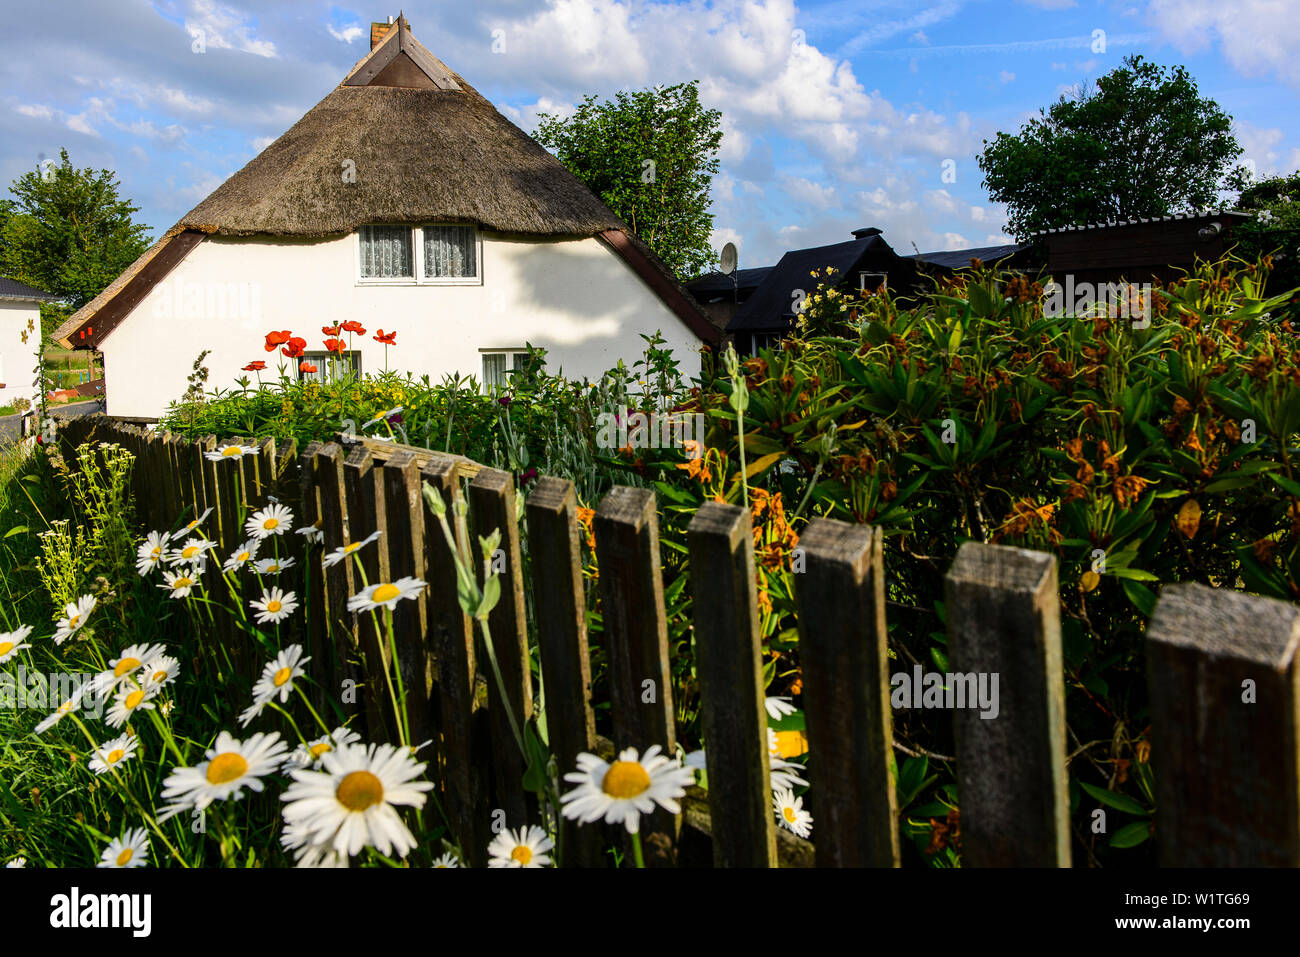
[594,485,680,866]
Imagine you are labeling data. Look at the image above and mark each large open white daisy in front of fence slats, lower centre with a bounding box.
[560,745,696,833]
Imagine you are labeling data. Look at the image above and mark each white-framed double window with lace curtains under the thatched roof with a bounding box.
[356,224,482,286]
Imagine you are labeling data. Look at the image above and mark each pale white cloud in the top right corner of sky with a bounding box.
[1147,0,1300,85]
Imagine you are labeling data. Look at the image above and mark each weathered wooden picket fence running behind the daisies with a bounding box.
[60,415,1300,867]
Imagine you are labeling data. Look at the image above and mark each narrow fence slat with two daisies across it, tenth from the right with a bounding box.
[343,446,397,741]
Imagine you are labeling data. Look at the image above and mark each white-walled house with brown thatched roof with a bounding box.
[56,17,722,417]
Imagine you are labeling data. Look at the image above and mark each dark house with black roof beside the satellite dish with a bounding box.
[727,226,920,355]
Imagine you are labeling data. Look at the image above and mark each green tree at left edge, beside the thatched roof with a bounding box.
[0,150,150,321]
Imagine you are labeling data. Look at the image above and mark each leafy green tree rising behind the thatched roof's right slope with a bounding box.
[537,81,723,278]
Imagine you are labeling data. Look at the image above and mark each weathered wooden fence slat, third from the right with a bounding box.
[794,519,900,867]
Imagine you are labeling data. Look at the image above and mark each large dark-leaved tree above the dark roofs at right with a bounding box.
[979,56,1247,239]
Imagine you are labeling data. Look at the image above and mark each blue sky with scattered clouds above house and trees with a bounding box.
[0,0,1300,267]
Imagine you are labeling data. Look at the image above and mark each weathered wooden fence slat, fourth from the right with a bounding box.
[686,502,776,867]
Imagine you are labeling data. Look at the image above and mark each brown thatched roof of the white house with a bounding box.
[55,18,707,347]
